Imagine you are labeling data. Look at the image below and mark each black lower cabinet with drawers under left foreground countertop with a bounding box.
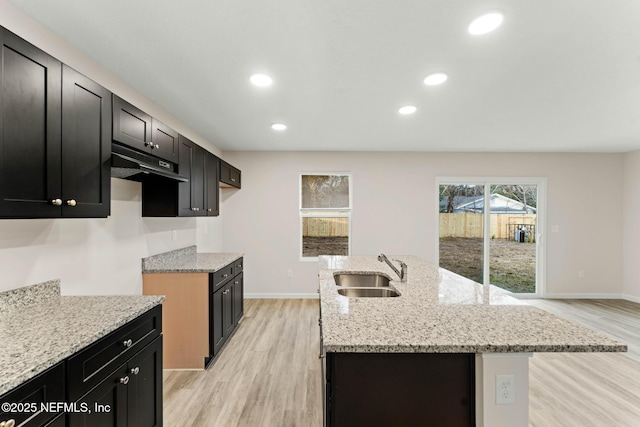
[0,306,163,427]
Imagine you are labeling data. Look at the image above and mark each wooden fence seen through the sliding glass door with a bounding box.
[440,213,536,239]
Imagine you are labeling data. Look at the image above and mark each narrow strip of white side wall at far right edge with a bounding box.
[623,151,640,302]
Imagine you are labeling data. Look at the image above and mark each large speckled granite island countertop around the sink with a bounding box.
[319,256,627,353]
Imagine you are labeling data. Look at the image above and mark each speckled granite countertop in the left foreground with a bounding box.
[0,280,164,395]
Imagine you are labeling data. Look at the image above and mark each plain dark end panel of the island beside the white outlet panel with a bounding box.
[324,353,475,427]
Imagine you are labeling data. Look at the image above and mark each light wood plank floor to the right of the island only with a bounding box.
[529,300,640,427]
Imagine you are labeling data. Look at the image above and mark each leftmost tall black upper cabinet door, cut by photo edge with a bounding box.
[0,28,62,218]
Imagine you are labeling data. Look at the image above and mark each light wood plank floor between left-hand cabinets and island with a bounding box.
[163,299,322,427]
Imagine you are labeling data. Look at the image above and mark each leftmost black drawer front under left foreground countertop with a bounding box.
[0,362,65,426]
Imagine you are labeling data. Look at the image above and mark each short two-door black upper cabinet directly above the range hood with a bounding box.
[113,95,179,163]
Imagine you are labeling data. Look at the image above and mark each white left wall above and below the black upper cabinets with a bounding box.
[0,0,222,295]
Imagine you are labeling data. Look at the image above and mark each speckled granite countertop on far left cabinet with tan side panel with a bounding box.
[142,246,244,274]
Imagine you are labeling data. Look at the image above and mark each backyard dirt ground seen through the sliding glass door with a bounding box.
[440,238,536,293]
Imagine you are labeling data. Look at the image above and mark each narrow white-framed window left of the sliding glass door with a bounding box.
[300,173,351,260]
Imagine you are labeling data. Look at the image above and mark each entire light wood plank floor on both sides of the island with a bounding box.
[164,300,640,427]
